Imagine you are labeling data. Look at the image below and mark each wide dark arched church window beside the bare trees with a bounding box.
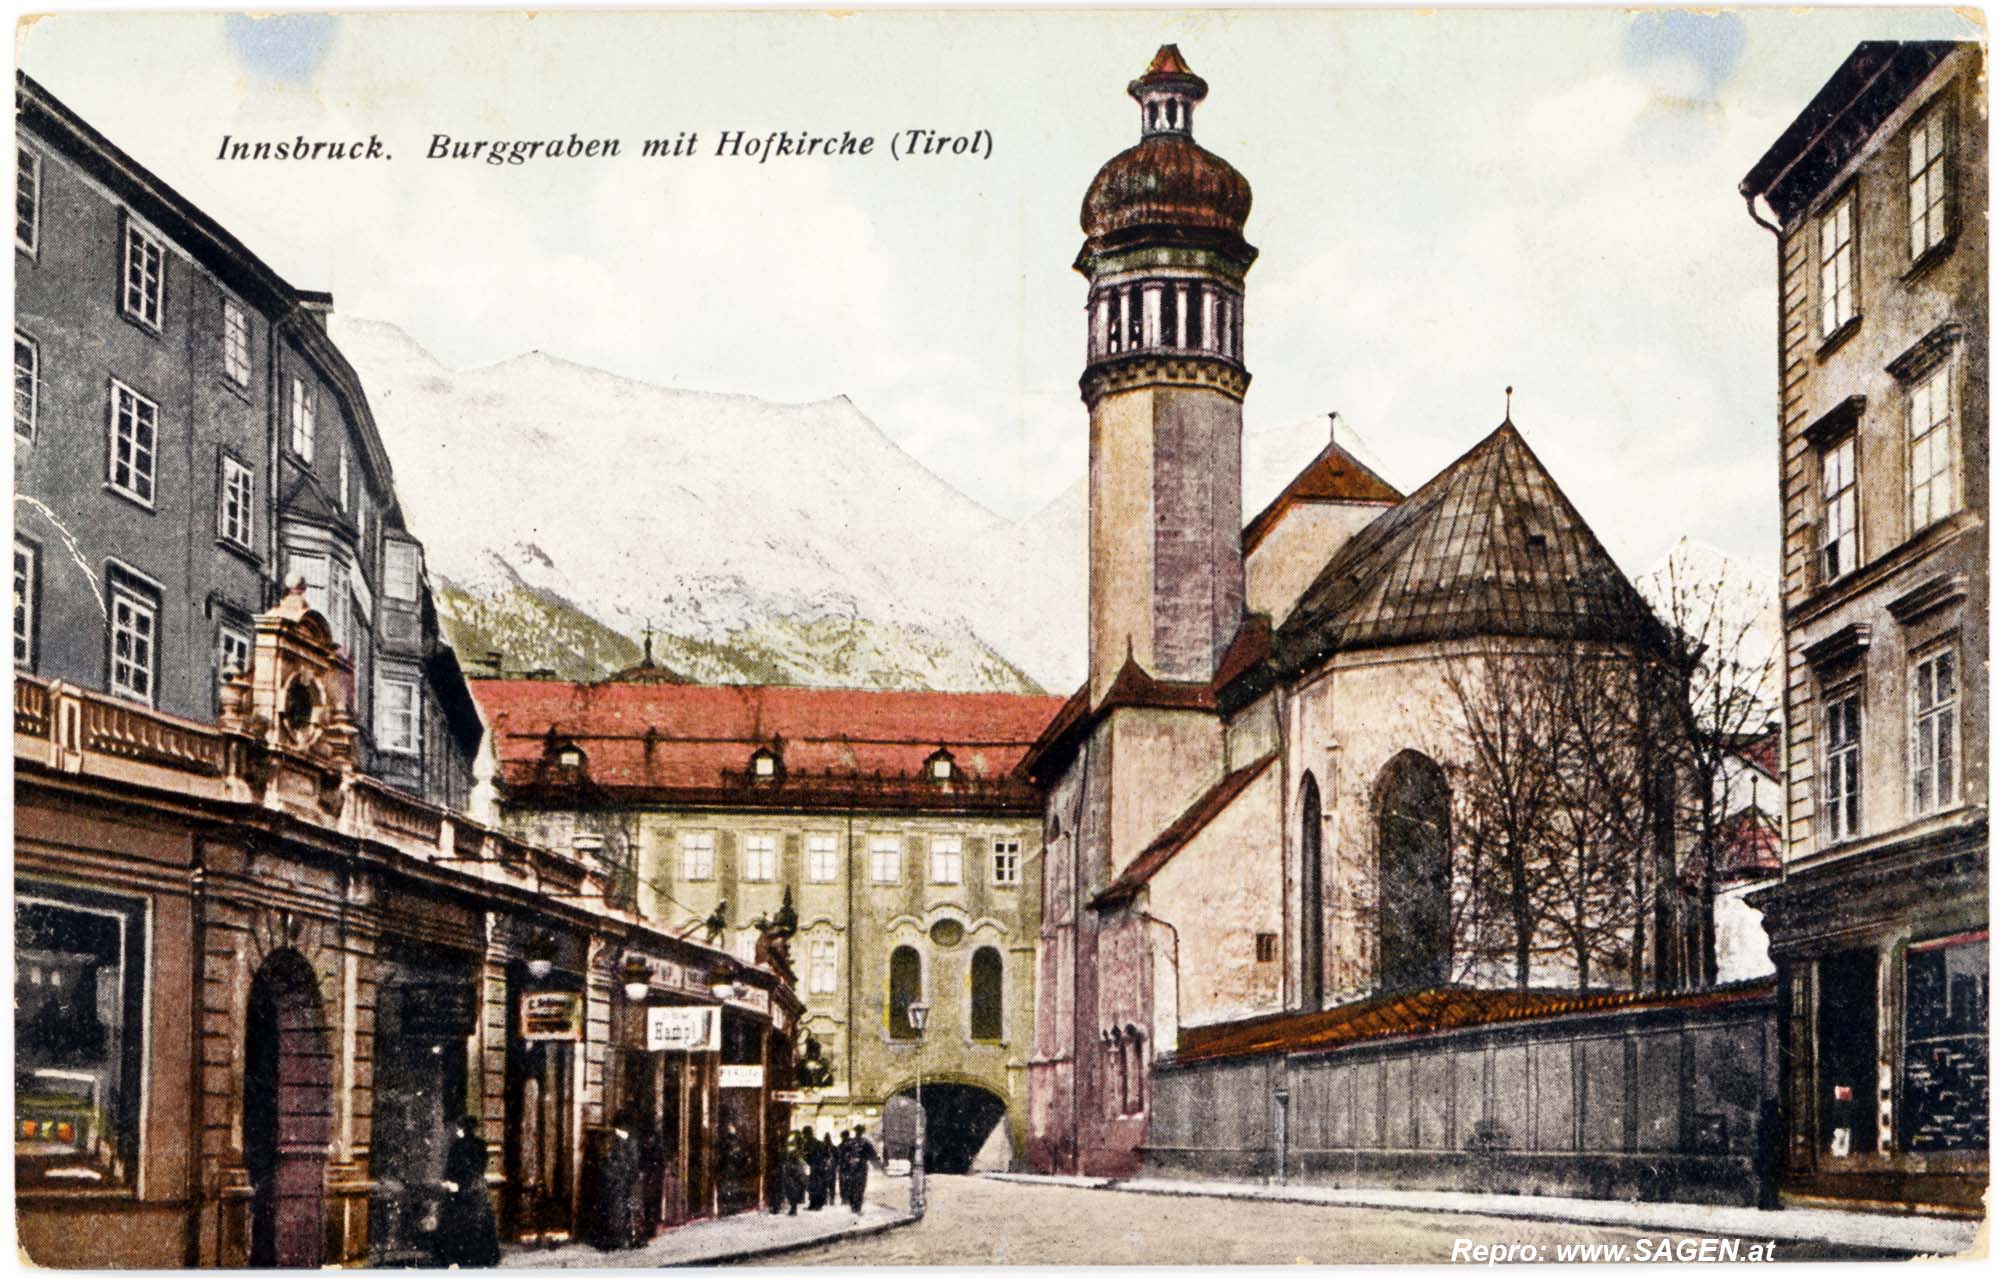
[1376,750,1452,990]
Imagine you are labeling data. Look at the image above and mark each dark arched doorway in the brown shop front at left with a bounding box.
[244,950,334,1270]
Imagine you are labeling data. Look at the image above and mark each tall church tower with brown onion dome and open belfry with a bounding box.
[1076,44,1256,704]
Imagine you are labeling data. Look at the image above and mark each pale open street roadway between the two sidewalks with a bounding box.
[764,1176,1920,1268]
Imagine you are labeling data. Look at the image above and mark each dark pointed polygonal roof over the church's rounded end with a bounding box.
[1274,420,1662,674]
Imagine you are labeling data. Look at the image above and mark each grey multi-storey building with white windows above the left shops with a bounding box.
[14,76,480,806]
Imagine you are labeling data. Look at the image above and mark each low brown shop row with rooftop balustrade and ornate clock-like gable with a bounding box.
[14,592,800,1268]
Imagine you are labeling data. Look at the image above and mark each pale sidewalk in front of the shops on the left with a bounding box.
[500,1176,914,1270]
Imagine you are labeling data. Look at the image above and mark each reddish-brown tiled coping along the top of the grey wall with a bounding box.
[1174,976,1778,1062]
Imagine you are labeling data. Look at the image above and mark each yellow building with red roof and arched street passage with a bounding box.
[472,666,1060,1170]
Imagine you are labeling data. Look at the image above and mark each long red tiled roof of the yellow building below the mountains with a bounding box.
[472,680,1062,800]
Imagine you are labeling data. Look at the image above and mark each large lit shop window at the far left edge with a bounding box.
[14,882,144,1188]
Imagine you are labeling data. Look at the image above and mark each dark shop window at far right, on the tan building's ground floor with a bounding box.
[1896,932,1990,1154]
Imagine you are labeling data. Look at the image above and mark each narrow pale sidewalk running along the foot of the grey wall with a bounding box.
[986,1172,1980,1256]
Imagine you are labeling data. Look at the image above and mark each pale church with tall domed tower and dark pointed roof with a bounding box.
[1022,46,1712,1178]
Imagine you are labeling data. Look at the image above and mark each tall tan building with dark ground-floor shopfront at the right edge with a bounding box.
[1740,42,1990,1210]
